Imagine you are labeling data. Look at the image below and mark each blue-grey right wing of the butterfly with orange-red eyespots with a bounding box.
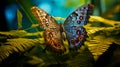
[64,4,93,50]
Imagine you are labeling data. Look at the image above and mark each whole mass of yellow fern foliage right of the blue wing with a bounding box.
[85,16,120,60]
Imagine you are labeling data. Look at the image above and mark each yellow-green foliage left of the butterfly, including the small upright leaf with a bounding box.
[0,10,44,62]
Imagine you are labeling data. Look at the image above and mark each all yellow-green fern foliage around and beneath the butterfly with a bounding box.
[0,6,120,67]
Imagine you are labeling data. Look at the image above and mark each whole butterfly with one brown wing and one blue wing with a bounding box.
[31,4,94,52]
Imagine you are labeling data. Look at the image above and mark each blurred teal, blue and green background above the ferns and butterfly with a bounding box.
[0,0,120,31]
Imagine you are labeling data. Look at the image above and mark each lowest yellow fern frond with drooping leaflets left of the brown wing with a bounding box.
[0,38,44,62]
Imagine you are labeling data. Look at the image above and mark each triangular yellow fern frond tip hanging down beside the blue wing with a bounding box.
[85,36,114,60]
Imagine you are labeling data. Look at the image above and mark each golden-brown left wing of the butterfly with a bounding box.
[31,6,65,52]
